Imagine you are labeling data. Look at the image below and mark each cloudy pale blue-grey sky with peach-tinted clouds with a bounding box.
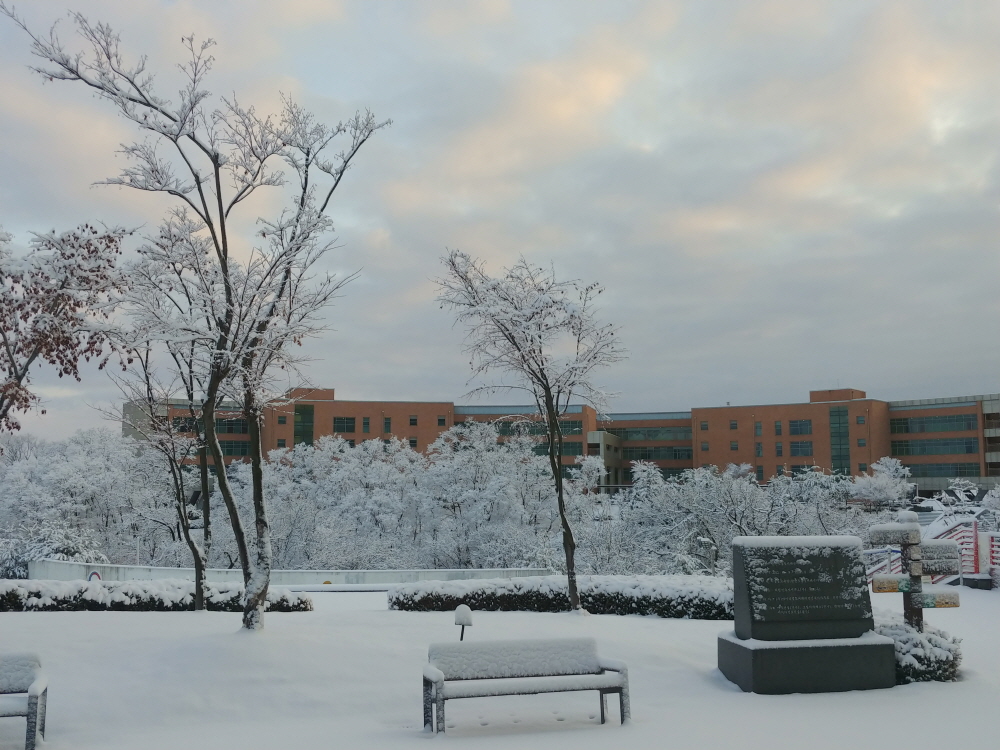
[0,0,1000,439]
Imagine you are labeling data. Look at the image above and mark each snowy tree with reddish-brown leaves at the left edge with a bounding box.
[0,225,126,432]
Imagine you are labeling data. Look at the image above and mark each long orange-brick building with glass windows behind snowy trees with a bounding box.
[135,388,1000,492]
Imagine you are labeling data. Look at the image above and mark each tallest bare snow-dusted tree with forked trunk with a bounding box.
[0,7,388,629]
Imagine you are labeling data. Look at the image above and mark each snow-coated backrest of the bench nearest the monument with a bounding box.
[427,638,601,680]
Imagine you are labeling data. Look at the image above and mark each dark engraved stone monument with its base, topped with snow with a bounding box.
[718,536,896,695]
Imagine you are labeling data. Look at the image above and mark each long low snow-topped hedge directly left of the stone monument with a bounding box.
[389,575,733,620]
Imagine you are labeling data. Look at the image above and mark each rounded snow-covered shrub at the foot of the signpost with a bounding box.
[875,612,962,685]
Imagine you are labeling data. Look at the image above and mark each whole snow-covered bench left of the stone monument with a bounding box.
[424,638,629,732]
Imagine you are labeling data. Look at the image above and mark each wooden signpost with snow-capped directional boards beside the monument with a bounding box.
[868,510,962,632]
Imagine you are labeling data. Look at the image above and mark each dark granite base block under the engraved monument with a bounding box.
[719,631,896,695]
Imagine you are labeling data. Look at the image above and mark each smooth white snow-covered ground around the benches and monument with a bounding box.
[0,589,1000,750]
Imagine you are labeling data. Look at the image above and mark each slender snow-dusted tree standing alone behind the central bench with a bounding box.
[438,250,624,609]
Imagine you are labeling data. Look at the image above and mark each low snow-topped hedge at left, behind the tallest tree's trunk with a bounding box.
[0,579,313,612]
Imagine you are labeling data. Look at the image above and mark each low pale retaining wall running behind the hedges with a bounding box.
[28,560,554,586]
